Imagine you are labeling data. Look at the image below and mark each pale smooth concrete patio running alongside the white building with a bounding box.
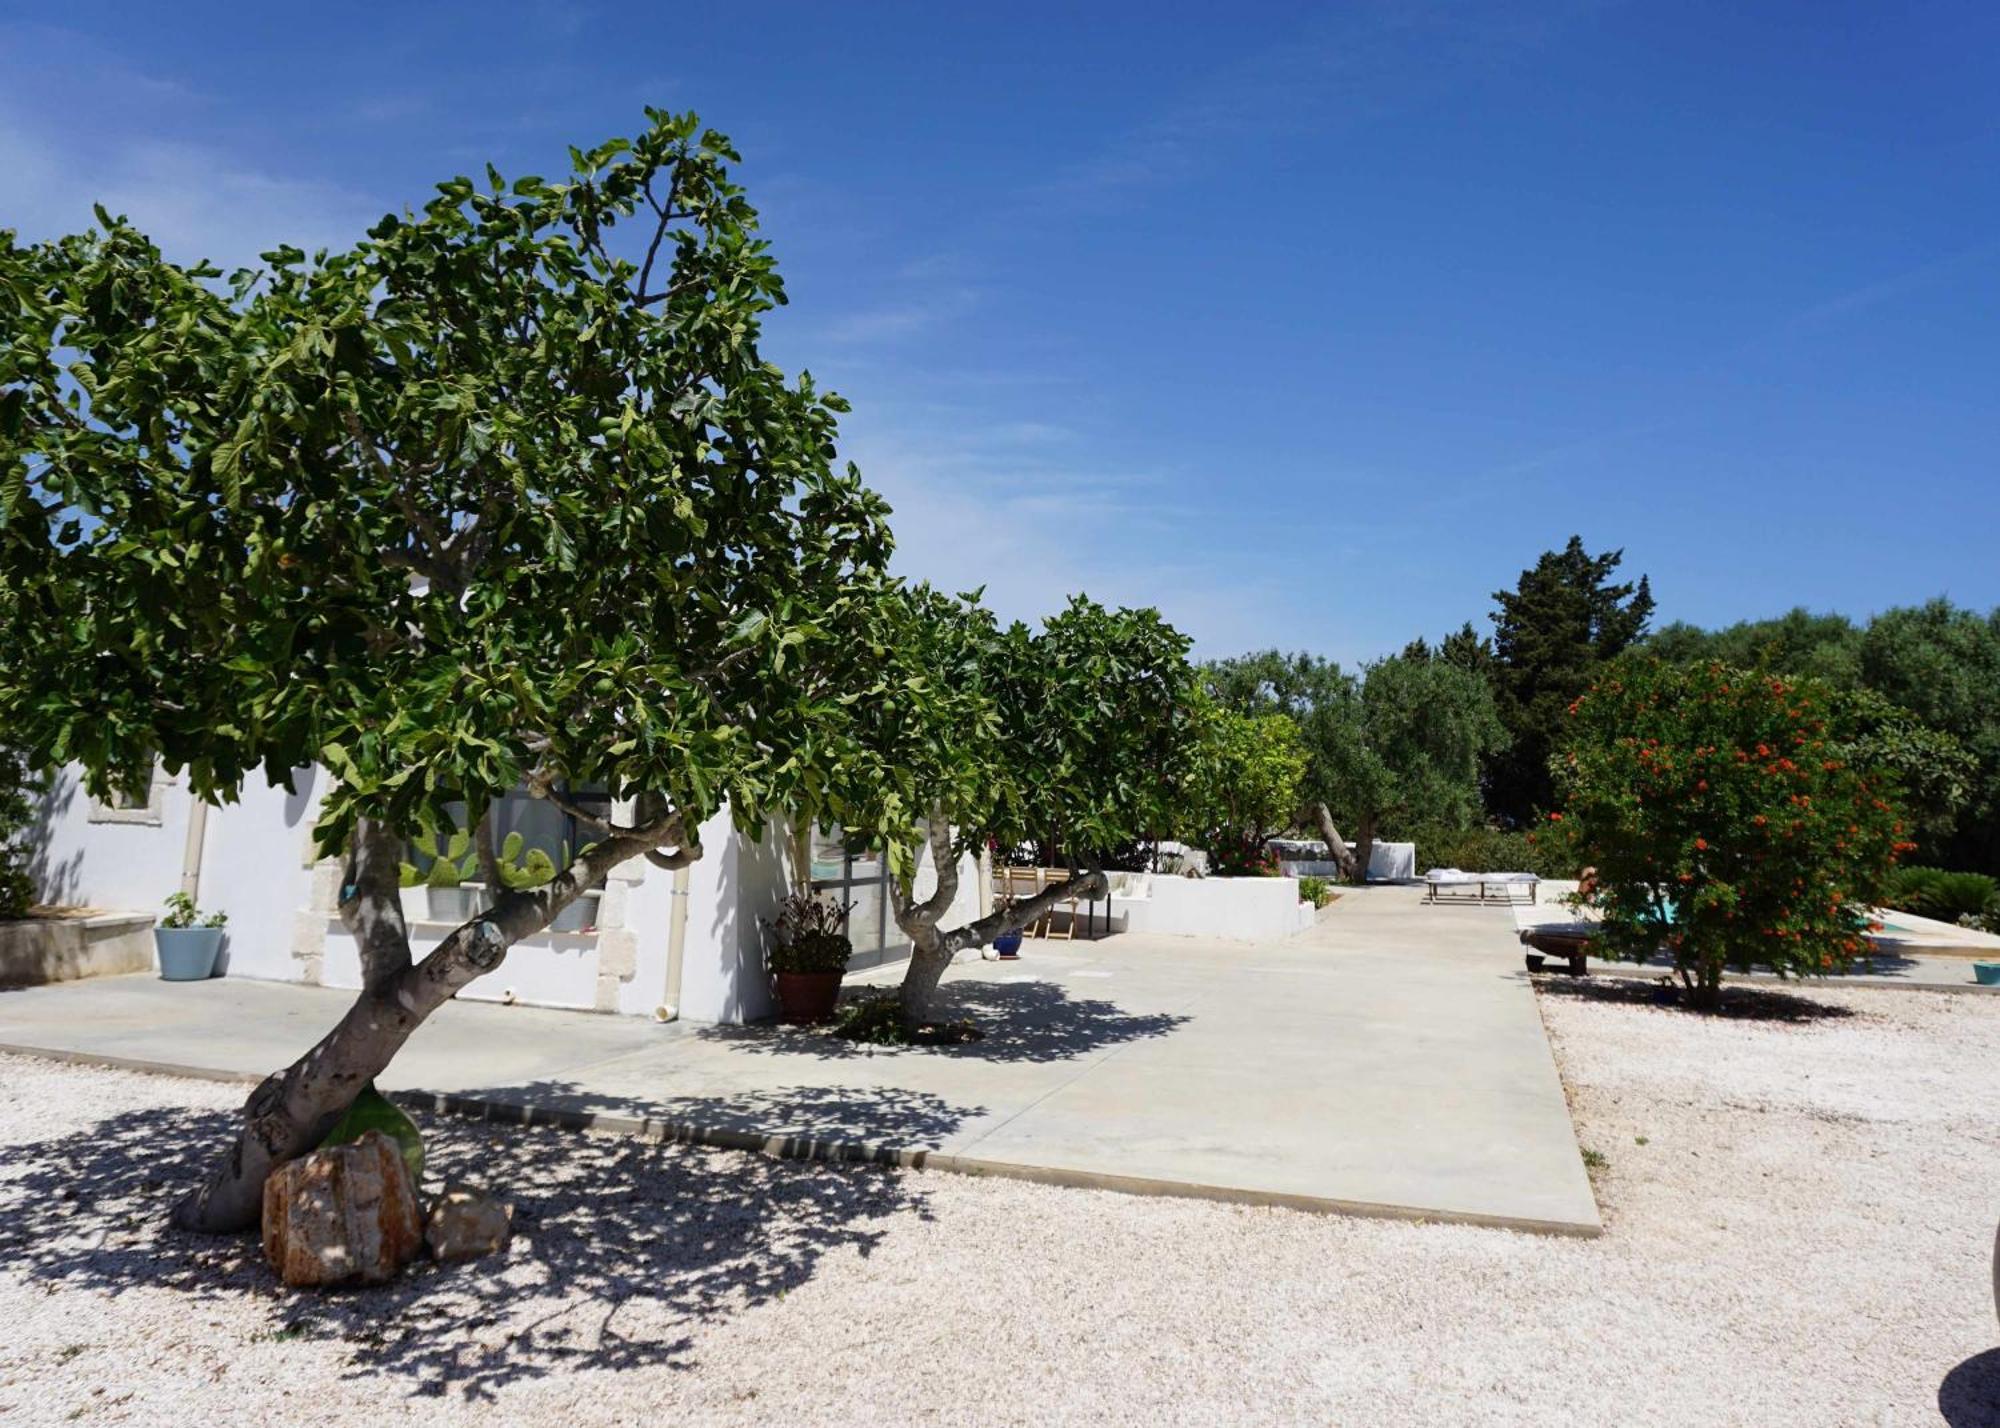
[0,888,1600,1234]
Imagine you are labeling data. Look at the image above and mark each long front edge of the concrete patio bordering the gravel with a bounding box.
[0,1042,1604,1240]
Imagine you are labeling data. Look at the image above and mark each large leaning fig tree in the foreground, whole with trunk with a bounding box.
[0,110,890,1230]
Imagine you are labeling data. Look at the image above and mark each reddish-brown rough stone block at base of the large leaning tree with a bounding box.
[264,1130,424,1288]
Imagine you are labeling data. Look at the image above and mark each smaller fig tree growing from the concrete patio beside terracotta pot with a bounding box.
[844,586,1194,1026]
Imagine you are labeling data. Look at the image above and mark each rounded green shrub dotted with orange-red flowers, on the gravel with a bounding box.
[1534,660,1916,1008]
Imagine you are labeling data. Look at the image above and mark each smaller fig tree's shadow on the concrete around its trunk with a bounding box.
[696,978,1190,1062]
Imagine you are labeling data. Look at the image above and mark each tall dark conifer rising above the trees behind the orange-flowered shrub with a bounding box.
[1486,536,1652,824]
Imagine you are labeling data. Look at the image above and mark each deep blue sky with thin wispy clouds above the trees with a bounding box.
[0,0,2000,660]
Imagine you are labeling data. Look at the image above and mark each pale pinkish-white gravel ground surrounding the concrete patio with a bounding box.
[0,984,2000,1428]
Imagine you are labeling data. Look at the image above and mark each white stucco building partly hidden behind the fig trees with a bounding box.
[21,768,990,1022]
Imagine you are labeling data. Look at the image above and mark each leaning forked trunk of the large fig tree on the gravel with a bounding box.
[174,820,700,1234]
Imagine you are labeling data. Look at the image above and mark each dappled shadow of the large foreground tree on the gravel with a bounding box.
[0,1088,960,1400]
